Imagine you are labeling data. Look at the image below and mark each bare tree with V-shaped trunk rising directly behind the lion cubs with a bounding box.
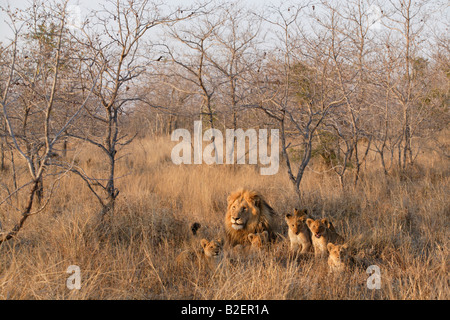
[248,4,344,202]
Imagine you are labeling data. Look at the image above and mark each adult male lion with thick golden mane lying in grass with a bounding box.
[225,189,276,247]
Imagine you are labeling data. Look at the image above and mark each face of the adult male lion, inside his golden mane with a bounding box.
[227,191,259,230]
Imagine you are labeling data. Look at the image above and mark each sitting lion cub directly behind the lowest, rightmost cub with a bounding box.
[306,218,344,257]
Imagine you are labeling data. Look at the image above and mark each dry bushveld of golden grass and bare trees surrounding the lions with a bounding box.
[0,0,450,300]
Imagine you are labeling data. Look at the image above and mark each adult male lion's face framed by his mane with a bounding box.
[227,190,261,230]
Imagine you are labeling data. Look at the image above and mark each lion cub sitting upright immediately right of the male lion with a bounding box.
[285,208,312,253]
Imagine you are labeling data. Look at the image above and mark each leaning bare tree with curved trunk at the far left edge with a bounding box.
[0,1,99,243]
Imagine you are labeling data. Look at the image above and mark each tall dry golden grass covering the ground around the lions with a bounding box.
[0,134,450,299]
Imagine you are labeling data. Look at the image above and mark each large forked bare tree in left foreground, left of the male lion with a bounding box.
[68,0,200,218]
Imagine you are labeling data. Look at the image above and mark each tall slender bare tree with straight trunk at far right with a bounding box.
[385,0,428,169]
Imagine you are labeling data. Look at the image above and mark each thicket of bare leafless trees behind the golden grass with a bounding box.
[0,0,450,242]
